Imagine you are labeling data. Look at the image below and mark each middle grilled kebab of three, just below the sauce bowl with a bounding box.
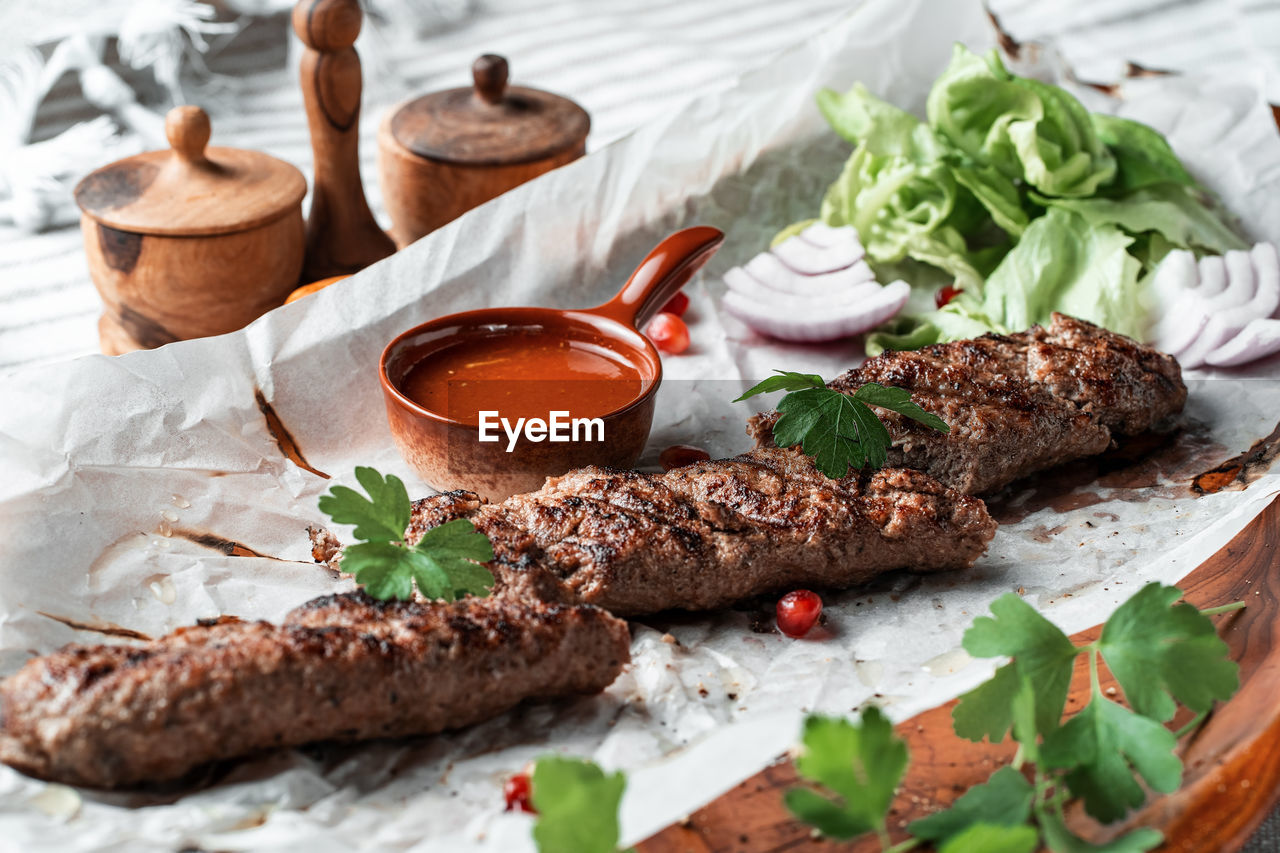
[406,440,996,616]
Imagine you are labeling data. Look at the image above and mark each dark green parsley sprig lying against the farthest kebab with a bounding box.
[733,370,951,479]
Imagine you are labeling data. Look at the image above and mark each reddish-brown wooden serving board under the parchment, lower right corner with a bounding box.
[636,498,1280,853]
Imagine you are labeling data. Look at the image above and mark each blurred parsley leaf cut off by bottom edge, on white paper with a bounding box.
[530,756,627,853]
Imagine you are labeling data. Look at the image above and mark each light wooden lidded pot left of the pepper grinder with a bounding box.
[76,106,307,355]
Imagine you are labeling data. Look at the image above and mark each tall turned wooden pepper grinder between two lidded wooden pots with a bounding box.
[293,0,396,282]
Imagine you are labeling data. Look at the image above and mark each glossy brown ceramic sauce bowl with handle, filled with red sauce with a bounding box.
[379,227,723,501]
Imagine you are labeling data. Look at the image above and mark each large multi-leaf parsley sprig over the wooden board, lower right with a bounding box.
[786,583,1243,853]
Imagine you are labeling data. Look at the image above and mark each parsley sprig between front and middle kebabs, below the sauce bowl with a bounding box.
[320,467,493,601]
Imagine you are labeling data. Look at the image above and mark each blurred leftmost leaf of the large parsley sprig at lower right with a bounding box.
[785,706,908,839]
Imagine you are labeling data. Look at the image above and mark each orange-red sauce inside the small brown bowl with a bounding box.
[401,332,645,424]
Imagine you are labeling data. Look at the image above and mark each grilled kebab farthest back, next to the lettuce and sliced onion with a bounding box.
[746,314,1187,494]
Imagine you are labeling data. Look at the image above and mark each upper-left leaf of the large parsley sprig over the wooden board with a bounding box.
[951,593,1079,743]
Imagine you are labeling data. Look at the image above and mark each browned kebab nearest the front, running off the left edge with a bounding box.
[0,592,630,788]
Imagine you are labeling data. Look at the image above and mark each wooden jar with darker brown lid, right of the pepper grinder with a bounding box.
[378,54,591,247]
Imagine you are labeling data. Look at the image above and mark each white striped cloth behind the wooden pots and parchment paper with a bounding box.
[0,0,1280,853]
